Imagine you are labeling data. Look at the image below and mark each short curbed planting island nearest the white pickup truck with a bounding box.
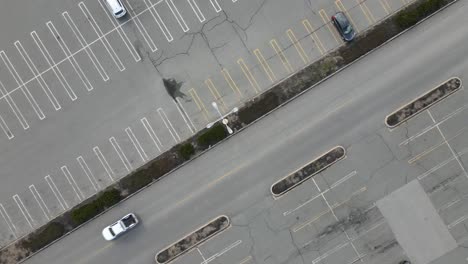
[155,215,230,264]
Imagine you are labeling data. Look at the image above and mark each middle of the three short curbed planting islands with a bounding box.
[271,146,346,197]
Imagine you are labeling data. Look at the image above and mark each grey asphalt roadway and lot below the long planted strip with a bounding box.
[19,2,468,264]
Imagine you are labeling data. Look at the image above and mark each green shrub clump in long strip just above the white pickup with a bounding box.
[71,189,122,226]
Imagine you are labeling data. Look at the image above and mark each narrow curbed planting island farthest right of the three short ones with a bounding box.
[385,77,462,128]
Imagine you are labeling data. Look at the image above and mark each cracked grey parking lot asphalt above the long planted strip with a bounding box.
[0,0,416,247]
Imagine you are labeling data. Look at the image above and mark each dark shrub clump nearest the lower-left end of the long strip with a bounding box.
[22,222,65,252]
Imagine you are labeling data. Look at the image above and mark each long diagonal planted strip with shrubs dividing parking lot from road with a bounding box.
[0,0,457,264]
